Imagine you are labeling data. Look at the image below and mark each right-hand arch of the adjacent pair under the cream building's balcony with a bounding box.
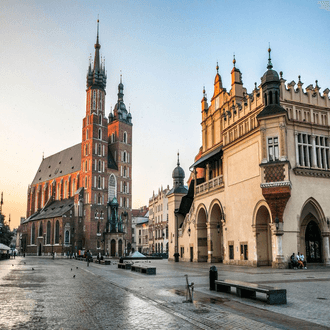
[208,203,223,262]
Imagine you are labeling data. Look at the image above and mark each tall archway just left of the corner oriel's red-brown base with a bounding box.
[255,206,272,266]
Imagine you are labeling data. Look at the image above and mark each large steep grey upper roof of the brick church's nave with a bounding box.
[32,143,81,185]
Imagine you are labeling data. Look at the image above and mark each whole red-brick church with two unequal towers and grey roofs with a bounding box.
[19,23,132,256]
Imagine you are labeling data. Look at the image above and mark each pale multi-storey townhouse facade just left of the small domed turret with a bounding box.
[148,186,170,253]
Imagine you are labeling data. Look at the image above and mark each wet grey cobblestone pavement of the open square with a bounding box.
[0,257,330,329]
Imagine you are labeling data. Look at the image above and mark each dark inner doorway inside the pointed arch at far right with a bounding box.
[305,220,322,263]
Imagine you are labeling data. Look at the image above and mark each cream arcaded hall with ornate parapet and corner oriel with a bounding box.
[168,49,330,268]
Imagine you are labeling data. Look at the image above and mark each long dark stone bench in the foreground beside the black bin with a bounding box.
[215,280,286,305]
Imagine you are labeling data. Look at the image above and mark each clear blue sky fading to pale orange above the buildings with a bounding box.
[0,0,330,228]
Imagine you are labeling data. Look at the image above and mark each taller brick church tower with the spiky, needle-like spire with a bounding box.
[80,20,108,251]
